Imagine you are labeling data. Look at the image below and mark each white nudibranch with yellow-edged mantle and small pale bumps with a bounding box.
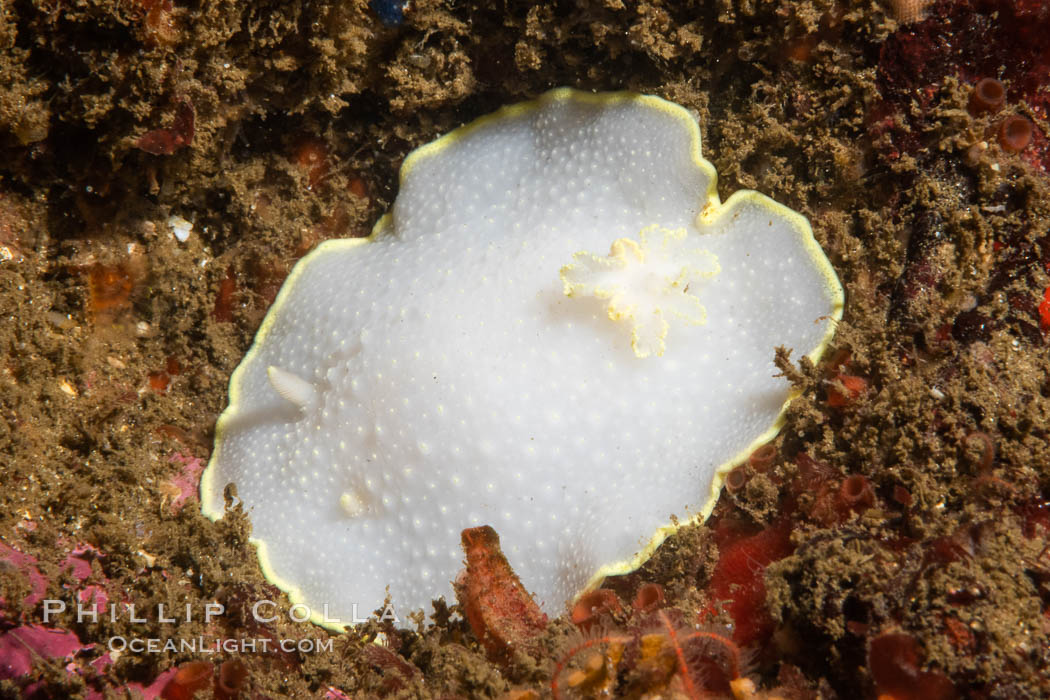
[201,88,843,627]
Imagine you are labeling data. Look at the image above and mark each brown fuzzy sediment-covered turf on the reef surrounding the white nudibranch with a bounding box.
[0,0,1050,697]
